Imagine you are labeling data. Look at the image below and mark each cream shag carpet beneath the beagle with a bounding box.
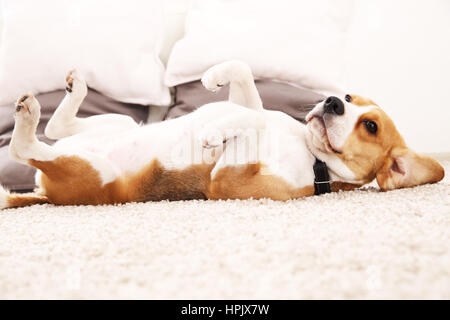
[0,161,450,299]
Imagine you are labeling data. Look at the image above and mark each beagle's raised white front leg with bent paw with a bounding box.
[202,60,264,111]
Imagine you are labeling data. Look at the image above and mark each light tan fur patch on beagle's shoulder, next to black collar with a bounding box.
[207,163,314,201]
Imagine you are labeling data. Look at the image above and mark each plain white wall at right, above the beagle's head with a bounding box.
[346,0,450,153]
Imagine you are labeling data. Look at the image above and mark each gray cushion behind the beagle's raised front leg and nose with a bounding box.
[166,79,325,122]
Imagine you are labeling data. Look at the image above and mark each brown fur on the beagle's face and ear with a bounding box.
[338,108,444,190]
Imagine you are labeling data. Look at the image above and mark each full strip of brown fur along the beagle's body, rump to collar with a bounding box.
[29,156,314,205]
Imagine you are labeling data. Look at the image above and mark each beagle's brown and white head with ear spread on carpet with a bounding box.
[306,95,444,190]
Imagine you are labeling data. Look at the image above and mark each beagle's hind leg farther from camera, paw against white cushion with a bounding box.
[45,70,138,140]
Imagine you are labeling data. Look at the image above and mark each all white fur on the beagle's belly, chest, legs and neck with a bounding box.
[10,61,364,195]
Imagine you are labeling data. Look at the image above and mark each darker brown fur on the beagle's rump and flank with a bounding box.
[29,156,217,205]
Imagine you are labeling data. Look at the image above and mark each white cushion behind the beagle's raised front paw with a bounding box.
[165,0,352,89]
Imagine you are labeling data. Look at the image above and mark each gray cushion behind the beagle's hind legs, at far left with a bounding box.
[0,90,148,191]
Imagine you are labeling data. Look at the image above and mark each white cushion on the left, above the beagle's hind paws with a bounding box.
[0,0,170,105]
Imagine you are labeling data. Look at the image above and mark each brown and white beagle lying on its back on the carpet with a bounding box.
[0,61,444,208]
